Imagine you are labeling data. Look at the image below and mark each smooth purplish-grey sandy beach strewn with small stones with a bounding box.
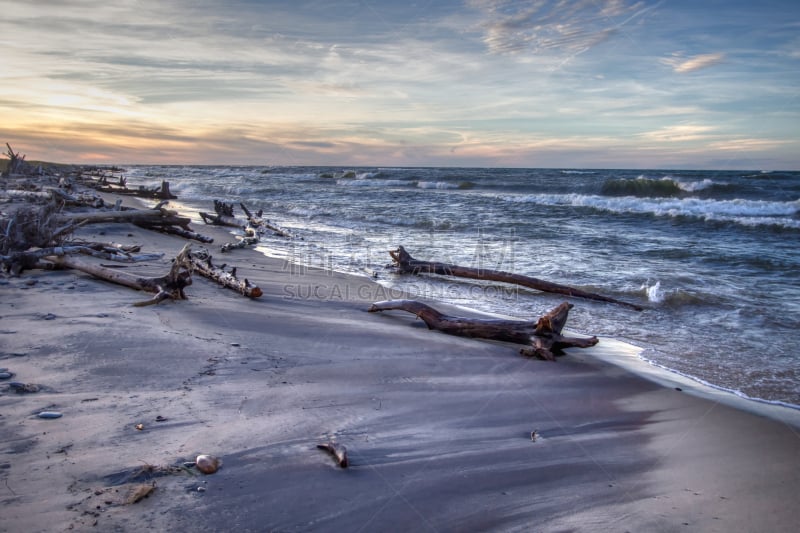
[0,190,800,533]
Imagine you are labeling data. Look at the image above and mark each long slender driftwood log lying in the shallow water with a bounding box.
[389,246,642,311]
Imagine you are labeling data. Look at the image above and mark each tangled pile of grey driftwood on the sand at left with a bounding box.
[0,145,262,305]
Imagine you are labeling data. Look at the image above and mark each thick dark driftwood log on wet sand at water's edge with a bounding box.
[369,300,598,361]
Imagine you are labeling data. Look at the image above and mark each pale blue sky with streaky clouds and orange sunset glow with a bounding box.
[0,0,800,170]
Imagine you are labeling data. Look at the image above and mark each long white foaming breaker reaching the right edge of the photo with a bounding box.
[498,193,800,230]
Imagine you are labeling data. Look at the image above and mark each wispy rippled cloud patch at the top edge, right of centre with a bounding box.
[469,0,646,55]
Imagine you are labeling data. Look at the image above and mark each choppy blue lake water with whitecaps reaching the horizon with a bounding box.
[123,166,800,406]
